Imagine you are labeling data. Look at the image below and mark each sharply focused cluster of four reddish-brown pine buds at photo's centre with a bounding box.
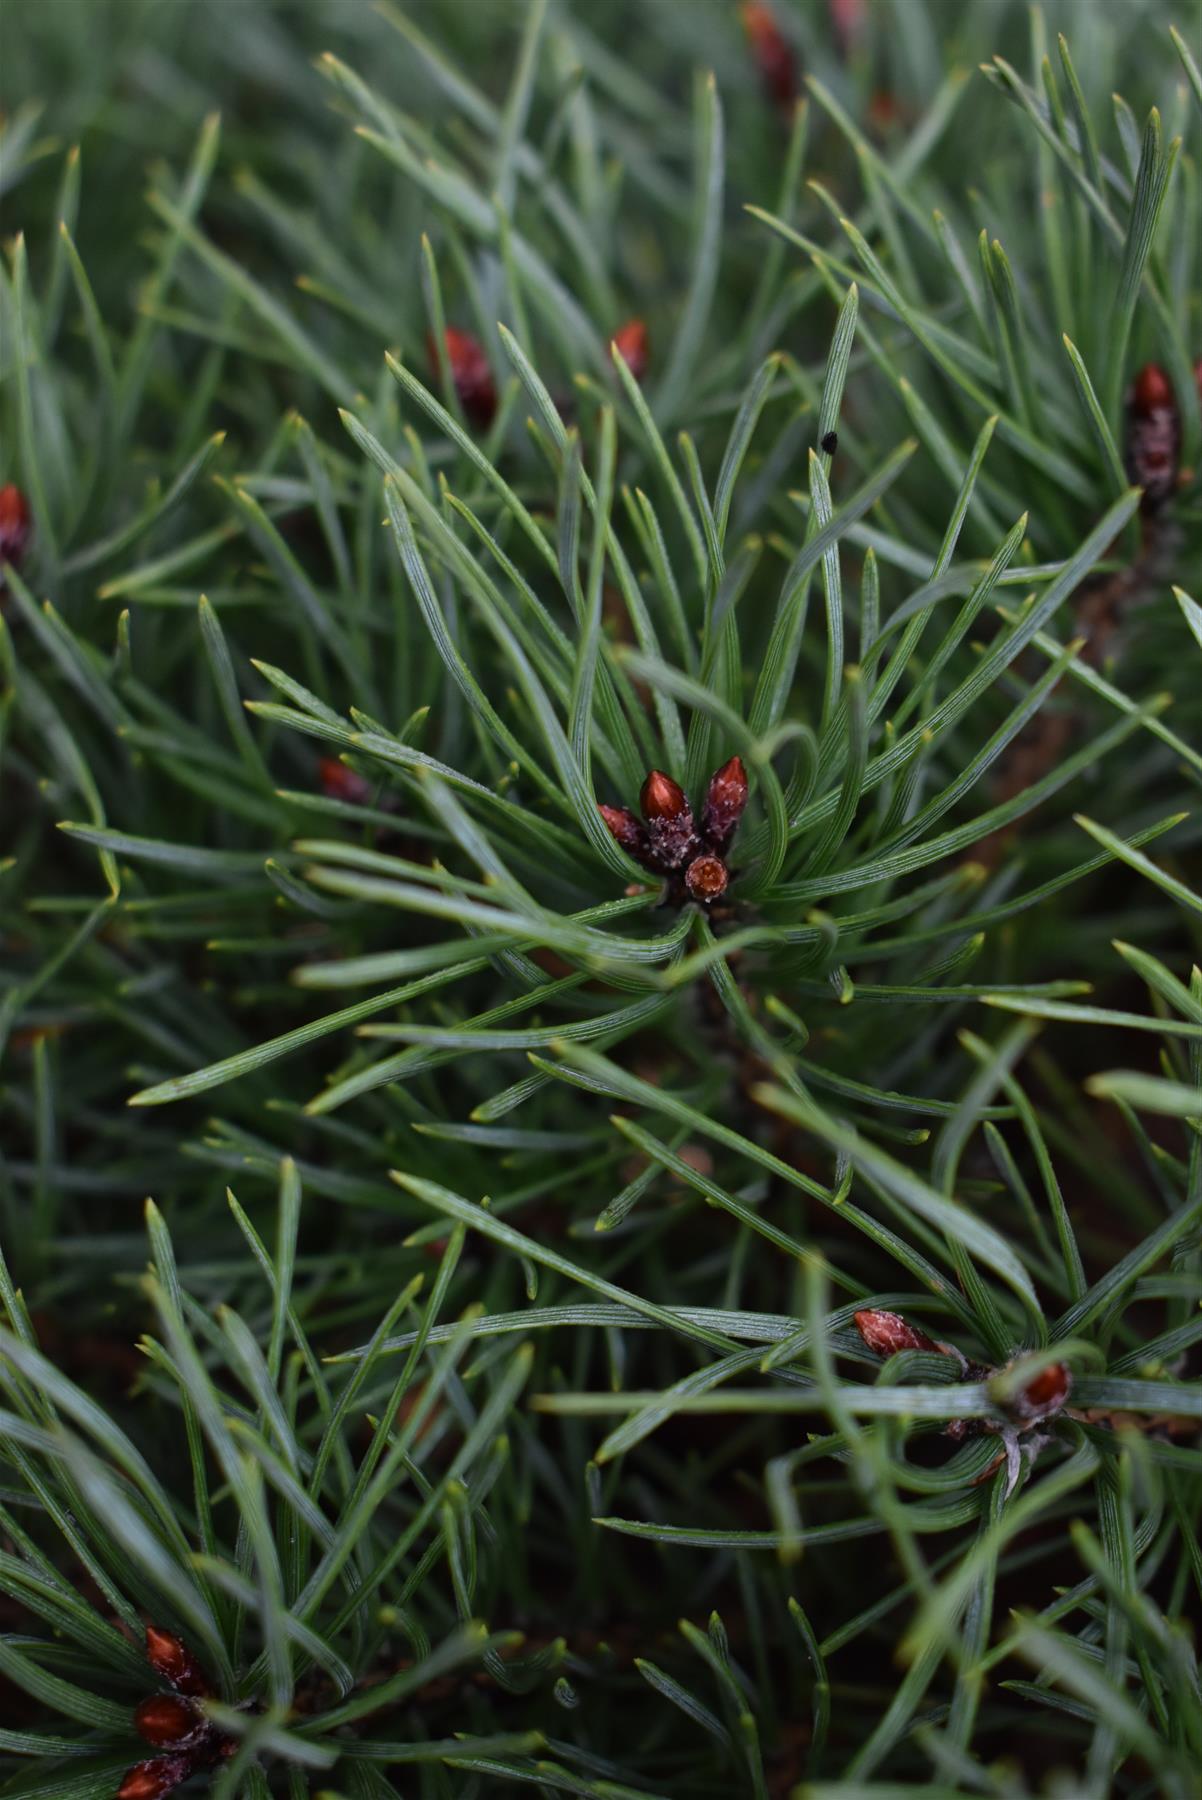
[597,756,747,905]
